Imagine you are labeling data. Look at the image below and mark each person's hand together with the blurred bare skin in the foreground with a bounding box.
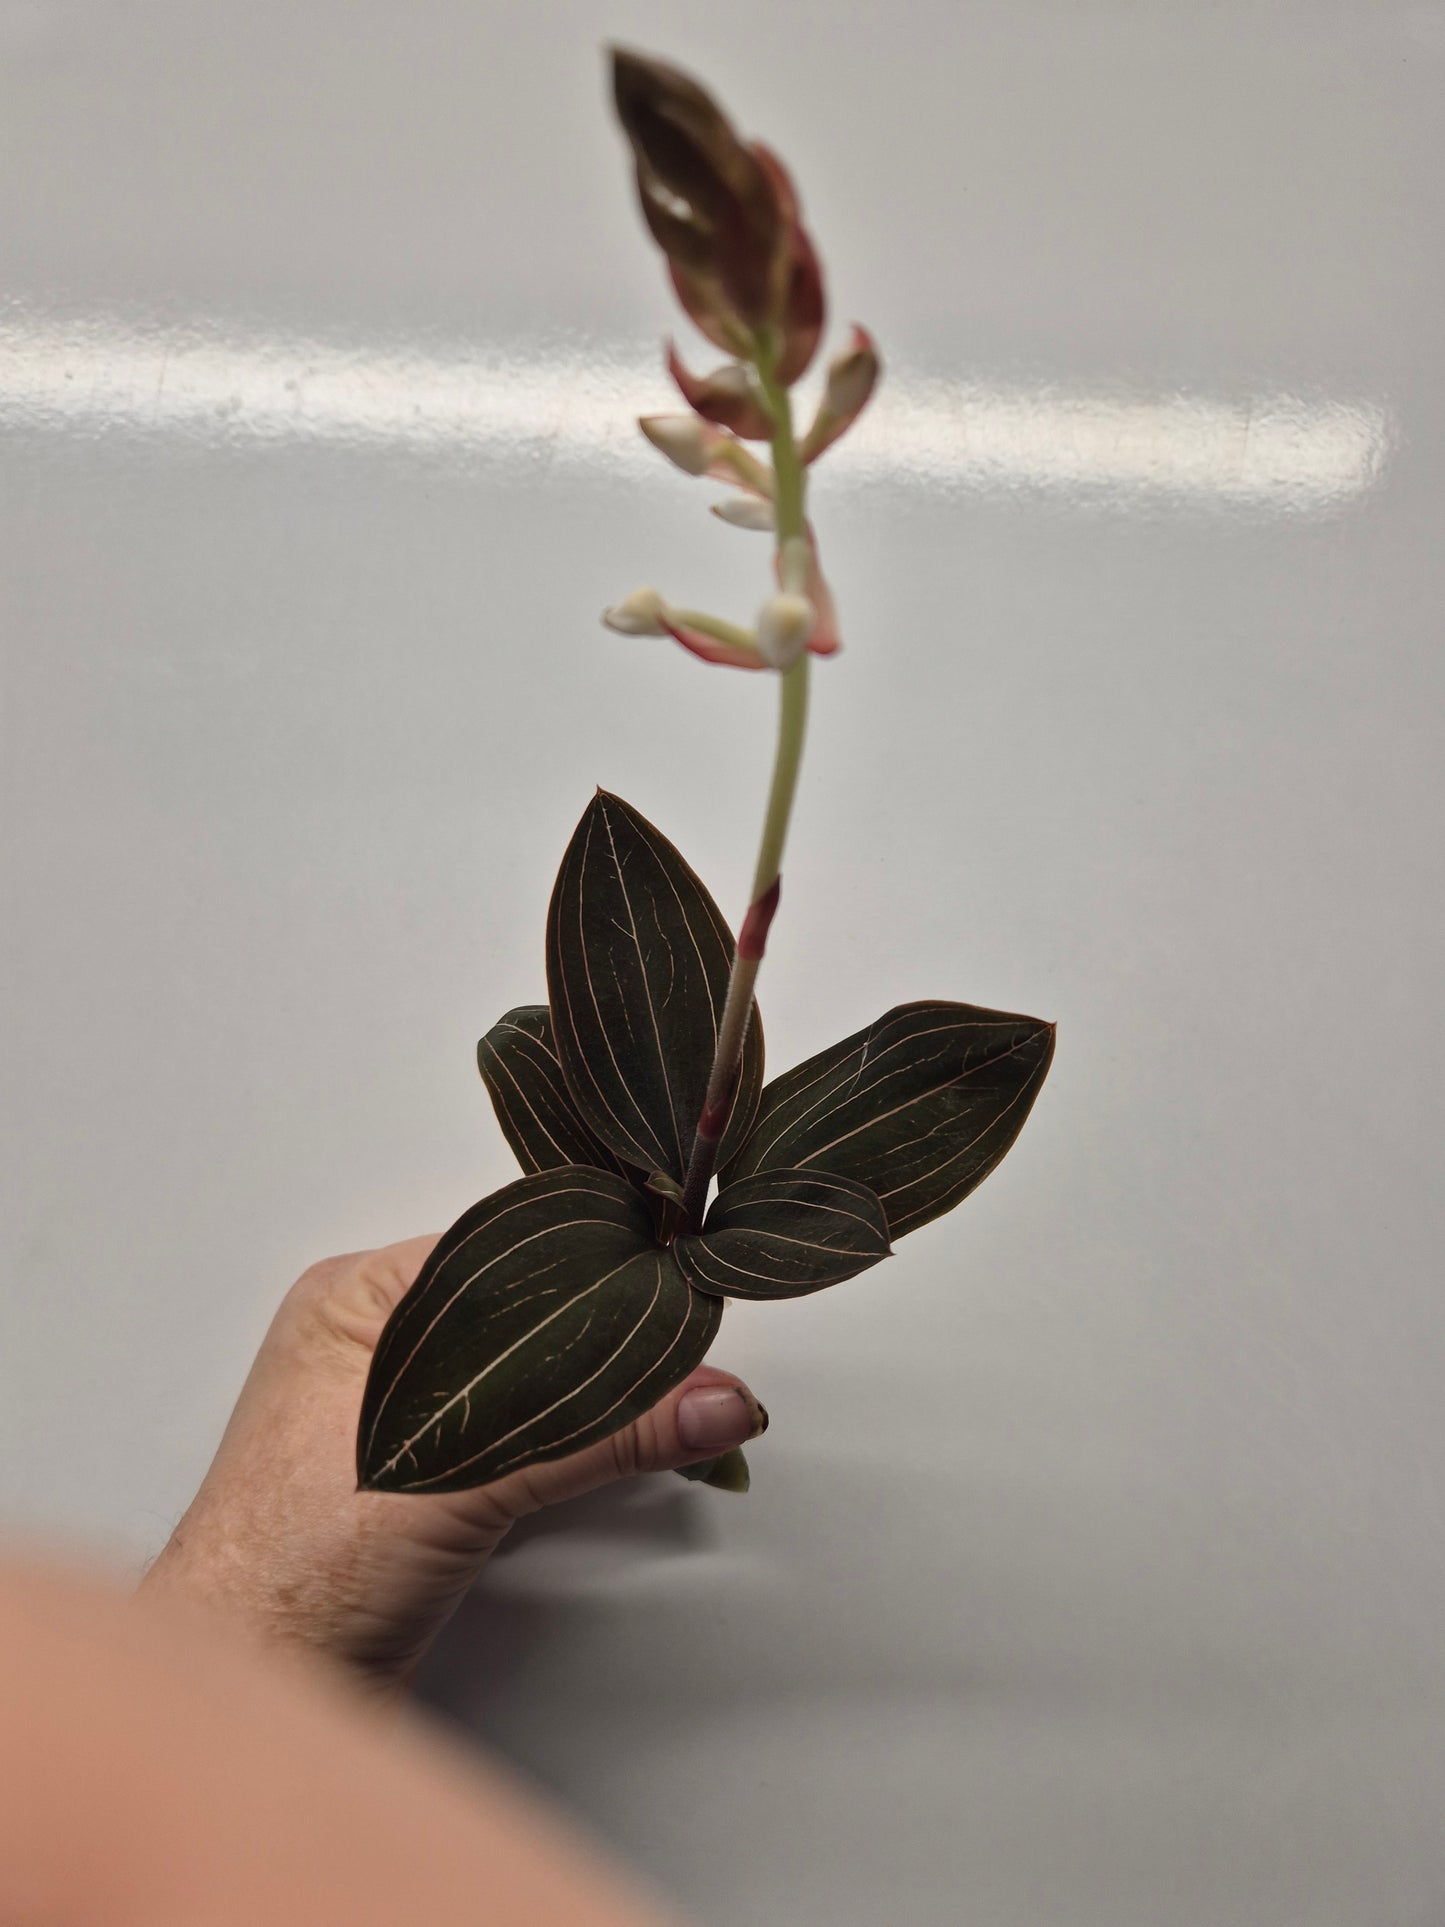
[0,1237,767,1927]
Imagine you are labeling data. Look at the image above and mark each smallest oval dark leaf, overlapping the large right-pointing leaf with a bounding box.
[672,1172,888,1299]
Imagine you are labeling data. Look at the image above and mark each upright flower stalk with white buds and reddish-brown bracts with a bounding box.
[605,48,879,1235]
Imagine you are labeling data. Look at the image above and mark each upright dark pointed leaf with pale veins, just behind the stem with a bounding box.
[547,790,763,1177]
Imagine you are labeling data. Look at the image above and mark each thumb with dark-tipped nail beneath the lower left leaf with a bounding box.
[486,1364,767,1518]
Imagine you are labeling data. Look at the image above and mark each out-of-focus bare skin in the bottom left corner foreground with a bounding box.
[0,1561,676,1927]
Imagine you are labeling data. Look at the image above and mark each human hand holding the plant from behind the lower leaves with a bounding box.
[143,1237,767,1696]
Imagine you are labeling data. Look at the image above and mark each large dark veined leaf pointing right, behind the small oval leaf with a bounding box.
[723,1002,1054,1237]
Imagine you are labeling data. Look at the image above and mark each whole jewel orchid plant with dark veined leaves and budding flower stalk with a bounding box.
[356,50,1054,1491]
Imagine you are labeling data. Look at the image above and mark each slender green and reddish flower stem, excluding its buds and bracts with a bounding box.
[682,358,809,1231]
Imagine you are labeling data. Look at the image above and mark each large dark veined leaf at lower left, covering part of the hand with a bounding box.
[356,1166,723,1491]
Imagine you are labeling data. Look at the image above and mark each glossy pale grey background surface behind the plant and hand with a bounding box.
[0,0,1445,1927]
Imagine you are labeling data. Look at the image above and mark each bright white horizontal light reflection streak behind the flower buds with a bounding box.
[0,310,1393,513]
